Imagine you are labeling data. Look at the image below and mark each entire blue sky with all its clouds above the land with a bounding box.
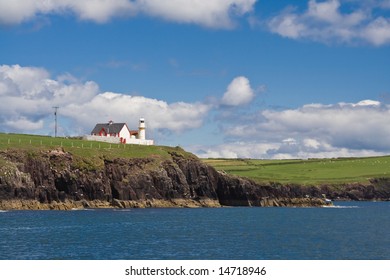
[0,0,390,159]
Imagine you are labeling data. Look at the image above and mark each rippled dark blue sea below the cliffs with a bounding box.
[0,202,390,260]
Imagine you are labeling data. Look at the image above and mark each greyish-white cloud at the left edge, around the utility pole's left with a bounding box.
[0,65,98,132]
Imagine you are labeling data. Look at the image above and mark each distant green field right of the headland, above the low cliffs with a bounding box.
[204,156,390,185]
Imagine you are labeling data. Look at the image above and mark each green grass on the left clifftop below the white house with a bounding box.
[0,133,192,169]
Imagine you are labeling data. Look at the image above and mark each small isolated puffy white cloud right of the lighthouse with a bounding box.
[221,76,255,106]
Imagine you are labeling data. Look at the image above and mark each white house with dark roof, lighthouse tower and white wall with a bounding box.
[85,118,154,145]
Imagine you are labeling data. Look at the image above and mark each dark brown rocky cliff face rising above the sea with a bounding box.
[0,149,390,210]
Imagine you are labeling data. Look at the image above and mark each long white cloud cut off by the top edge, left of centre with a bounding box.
[0,0,256,28]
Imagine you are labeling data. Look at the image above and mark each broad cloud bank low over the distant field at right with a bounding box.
[189,100,390,158]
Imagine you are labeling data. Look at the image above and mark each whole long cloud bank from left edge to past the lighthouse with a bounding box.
[0,65,211,135]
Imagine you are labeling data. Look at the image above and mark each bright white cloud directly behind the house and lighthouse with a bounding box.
[62,92,210,132]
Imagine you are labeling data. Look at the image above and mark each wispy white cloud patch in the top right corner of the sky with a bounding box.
[268,0,390,46]
